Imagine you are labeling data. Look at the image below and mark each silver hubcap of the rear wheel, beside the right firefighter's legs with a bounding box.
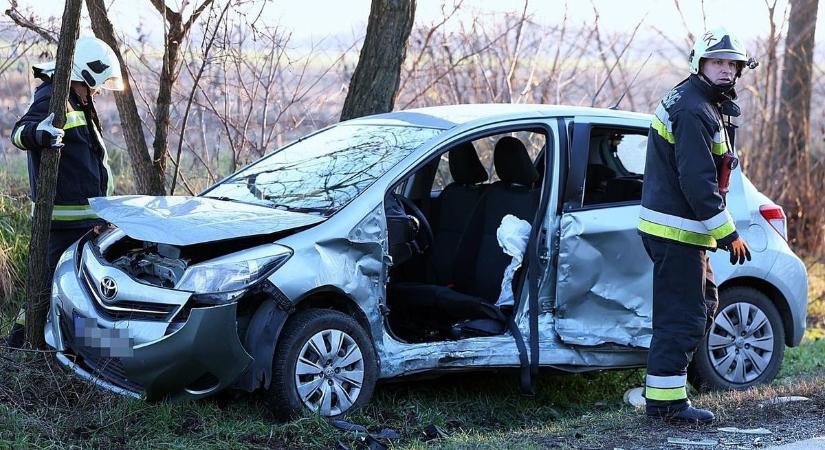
[708,302,774,384]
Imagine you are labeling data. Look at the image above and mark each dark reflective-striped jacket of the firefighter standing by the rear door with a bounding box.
[639,75,738,249]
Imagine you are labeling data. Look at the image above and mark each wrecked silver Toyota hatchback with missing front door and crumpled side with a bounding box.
[45,105,807,416]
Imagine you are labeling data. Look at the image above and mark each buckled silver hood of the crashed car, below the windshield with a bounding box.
[89,195,325,245]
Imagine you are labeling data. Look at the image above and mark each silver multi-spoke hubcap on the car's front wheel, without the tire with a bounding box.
[295,330,364,416]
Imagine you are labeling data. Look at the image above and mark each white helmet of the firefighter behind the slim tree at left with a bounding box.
[32,36,123,91]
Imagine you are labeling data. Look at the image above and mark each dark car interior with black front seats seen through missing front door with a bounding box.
[385,129,547,342]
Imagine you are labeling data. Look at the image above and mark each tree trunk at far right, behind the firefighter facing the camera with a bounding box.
[778,0,819,163]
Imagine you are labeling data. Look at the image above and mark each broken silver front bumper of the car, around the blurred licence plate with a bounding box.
[45,239,252,400]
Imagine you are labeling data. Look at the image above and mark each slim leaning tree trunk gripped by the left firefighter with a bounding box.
[26,0,83,348]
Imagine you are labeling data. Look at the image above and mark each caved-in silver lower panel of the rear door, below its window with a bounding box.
[555,206,652,347]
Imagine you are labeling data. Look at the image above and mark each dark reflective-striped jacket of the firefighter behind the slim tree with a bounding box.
[11,78,113,229]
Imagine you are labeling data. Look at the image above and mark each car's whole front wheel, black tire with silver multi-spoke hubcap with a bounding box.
[266,309,378,420]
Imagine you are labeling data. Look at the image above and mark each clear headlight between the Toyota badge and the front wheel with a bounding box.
[175,244,292,294]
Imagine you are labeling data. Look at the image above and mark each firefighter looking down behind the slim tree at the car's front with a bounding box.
[6,37,123,347]
